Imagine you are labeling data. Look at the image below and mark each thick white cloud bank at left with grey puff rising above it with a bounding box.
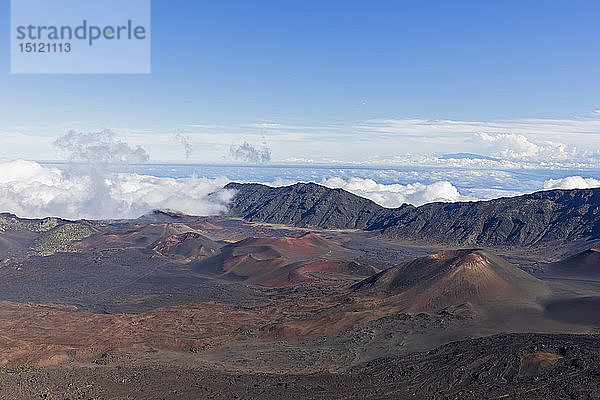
[0,130,233,219]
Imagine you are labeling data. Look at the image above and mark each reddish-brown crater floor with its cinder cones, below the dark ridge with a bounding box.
[0,213,600,399]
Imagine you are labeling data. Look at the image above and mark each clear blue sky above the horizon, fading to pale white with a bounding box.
[0,0,600,162]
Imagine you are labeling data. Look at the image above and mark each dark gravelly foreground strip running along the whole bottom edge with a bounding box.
[0,334,600,400]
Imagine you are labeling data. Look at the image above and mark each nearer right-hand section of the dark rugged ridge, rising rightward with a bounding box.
[382,189,600,246]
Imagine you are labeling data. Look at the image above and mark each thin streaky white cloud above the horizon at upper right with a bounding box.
[357,113,600,168]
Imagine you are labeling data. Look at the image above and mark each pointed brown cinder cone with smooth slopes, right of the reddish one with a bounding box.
[354,249,549,311]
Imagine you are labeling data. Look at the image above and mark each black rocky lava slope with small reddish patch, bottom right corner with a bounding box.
[350,333,600,399]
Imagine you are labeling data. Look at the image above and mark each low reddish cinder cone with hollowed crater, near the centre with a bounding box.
[195,232,378,287]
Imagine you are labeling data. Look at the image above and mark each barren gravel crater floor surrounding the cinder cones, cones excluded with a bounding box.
[0,216,600,400]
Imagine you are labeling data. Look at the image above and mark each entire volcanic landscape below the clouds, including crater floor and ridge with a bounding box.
[0,184,600,399]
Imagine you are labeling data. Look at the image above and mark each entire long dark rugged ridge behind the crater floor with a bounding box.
[226,183,600,246]
